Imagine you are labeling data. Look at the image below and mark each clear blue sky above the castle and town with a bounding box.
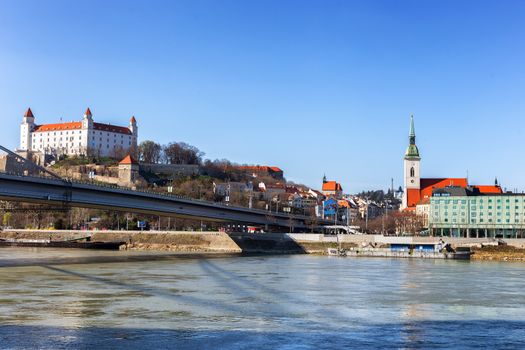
[0,0,525,192]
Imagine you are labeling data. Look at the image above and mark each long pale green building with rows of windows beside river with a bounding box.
[429,187,525,238]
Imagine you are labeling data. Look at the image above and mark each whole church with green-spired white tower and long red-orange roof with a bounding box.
[401,116,503,212]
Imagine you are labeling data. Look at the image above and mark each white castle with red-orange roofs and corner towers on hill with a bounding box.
[19,108,138,157]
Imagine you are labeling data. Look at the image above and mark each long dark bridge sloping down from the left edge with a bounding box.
[0,146,333,230]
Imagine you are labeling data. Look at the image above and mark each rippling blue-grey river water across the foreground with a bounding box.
[0,248,525,349]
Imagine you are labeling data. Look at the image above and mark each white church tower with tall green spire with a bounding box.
[401,116,421,209]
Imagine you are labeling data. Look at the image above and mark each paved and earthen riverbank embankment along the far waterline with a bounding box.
[0,230,525,261]
